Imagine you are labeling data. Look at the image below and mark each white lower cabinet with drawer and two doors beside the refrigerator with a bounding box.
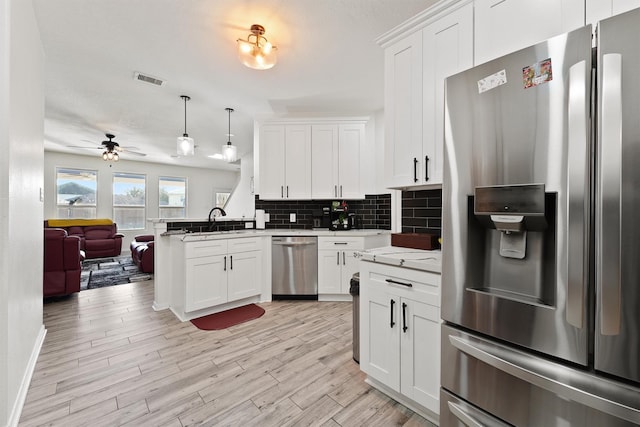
[360,261,440,416]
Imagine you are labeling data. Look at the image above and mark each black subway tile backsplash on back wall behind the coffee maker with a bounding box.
[255,194,391,230]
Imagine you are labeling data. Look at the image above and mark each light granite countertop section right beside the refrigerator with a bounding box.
[359,246,442,273]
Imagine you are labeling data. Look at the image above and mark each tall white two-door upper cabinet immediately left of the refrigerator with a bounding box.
[385,2,473,188]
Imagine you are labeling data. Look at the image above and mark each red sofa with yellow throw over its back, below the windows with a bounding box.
[44,219,124,258]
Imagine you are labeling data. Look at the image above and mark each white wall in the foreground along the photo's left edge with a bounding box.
[0,0,45,426]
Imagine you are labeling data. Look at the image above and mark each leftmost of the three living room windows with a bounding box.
[56,168,98,218]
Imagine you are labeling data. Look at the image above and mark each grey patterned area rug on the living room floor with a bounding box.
[80,255,153,291]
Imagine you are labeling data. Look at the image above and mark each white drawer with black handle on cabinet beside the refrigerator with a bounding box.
[360,261,440,307]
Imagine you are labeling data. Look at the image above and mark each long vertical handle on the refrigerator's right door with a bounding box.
[596,53,622,335]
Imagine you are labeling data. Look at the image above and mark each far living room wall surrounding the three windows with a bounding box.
[44,151,242,252]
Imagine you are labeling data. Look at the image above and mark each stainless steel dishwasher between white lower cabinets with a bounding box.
[271,236,318,300]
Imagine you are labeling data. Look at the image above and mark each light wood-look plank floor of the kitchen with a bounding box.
[19,281,433,427]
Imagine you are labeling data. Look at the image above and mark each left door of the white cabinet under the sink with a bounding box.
[185,255,227,312]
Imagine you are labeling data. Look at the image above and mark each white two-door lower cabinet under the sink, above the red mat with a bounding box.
[176,237,262,313]
